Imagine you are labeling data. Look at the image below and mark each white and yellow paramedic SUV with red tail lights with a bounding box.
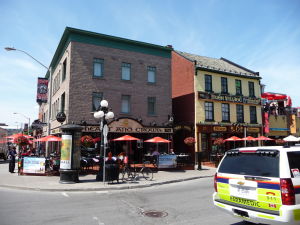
[213,146,300,225]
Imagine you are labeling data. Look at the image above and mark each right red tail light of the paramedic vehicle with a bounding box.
[280,178,295,205]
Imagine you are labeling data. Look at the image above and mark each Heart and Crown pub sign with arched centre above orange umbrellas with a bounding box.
[83,118,173,134]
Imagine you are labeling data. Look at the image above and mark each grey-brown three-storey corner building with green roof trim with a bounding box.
[40,27,173,157]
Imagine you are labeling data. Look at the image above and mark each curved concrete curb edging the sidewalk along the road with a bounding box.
[0,175,214,192]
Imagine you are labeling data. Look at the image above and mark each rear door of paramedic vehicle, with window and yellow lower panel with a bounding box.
[216,149,282,215]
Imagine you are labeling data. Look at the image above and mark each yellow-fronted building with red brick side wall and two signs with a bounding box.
[172,51,262,166]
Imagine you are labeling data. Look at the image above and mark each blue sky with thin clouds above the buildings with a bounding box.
[0,0,300,127]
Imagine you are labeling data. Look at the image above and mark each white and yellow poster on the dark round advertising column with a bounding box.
[60,135,72,169]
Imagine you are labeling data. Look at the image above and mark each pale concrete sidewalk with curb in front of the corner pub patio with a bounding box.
[0,161,216,191]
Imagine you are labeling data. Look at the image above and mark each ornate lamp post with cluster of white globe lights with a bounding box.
[94,100,114,183]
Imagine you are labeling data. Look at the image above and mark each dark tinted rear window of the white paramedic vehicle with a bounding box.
[219,153,279,177]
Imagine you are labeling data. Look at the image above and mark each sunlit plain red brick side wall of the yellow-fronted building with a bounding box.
[172,51,195,98]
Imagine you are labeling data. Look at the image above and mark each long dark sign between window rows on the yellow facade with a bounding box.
[198,91,261,105]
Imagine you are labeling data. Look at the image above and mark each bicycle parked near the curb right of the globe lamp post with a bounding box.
[122,161,153,181]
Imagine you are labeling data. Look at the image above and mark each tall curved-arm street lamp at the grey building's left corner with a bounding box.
[4,47,52,150]
